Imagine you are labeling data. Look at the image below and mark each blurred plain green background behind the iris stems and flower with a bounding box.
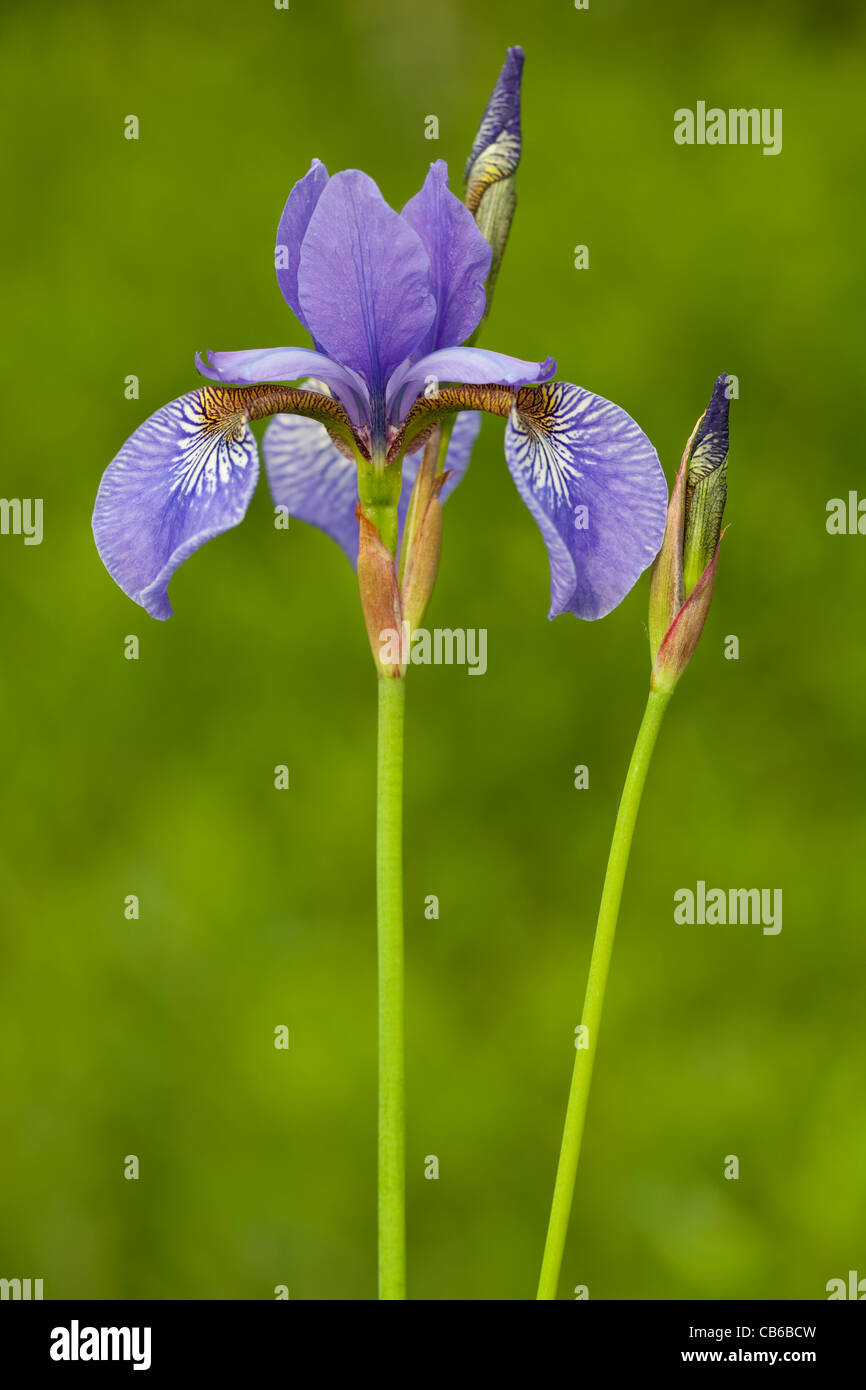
[0,0,866,1300]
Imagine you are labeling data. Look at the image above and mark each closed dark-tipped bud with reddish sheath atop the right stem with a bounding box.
[649,373,730,694]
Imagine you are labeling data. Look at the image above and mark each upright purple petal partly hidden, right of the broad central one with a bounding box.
[402,160,493,356]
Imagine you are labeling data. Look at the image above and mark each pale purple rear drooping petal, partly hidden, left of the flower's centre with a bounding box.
[261,416,357,566]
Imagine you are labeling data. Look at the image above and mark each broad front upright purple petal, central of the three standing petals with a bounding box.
[297,170,436,395]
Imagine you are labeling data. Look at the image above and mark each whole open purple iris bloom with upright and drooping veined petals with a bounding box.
[93,150,667,619]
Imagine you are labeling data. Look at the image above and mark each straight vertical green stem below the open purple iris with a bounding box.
[375,676,406,1298]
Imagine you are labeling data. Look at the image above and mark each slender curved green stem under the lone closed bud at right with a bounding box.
[538,691,670,1298]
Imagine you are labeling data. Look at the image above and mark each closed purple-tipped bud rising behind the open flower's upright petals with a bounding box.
[463,49,523,315]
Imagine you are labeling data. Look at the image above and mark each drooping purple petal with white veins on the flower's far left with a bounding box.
[93,386,259,619]
